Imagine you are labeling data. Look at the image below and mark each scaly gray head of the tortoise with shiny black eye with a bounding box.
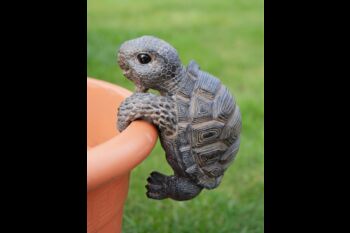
[118,36,183,92]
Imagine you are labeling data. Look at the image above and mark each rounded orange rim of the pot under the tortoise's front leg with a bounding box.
[87,77,158,191]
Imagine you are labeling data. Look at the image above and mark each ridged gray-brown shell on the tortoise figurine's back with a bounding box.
[161,61,241,189]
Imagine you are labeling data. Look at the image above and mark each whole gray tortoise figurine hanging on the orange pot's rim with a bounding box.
[117,36,242,201]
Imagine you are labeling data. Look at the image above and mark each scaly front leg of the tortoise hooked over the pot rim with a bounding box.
[117,93,176,136]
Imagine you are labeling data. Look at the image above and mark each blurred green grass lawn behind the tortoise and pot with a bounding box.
[87,0,264,233]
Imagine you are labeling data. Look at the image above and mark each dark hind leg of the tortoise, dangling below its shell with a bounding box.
[146,172,203,201]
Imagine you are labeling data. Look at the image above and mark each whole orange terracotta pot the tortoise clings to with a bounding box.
[87,78,157,233]
